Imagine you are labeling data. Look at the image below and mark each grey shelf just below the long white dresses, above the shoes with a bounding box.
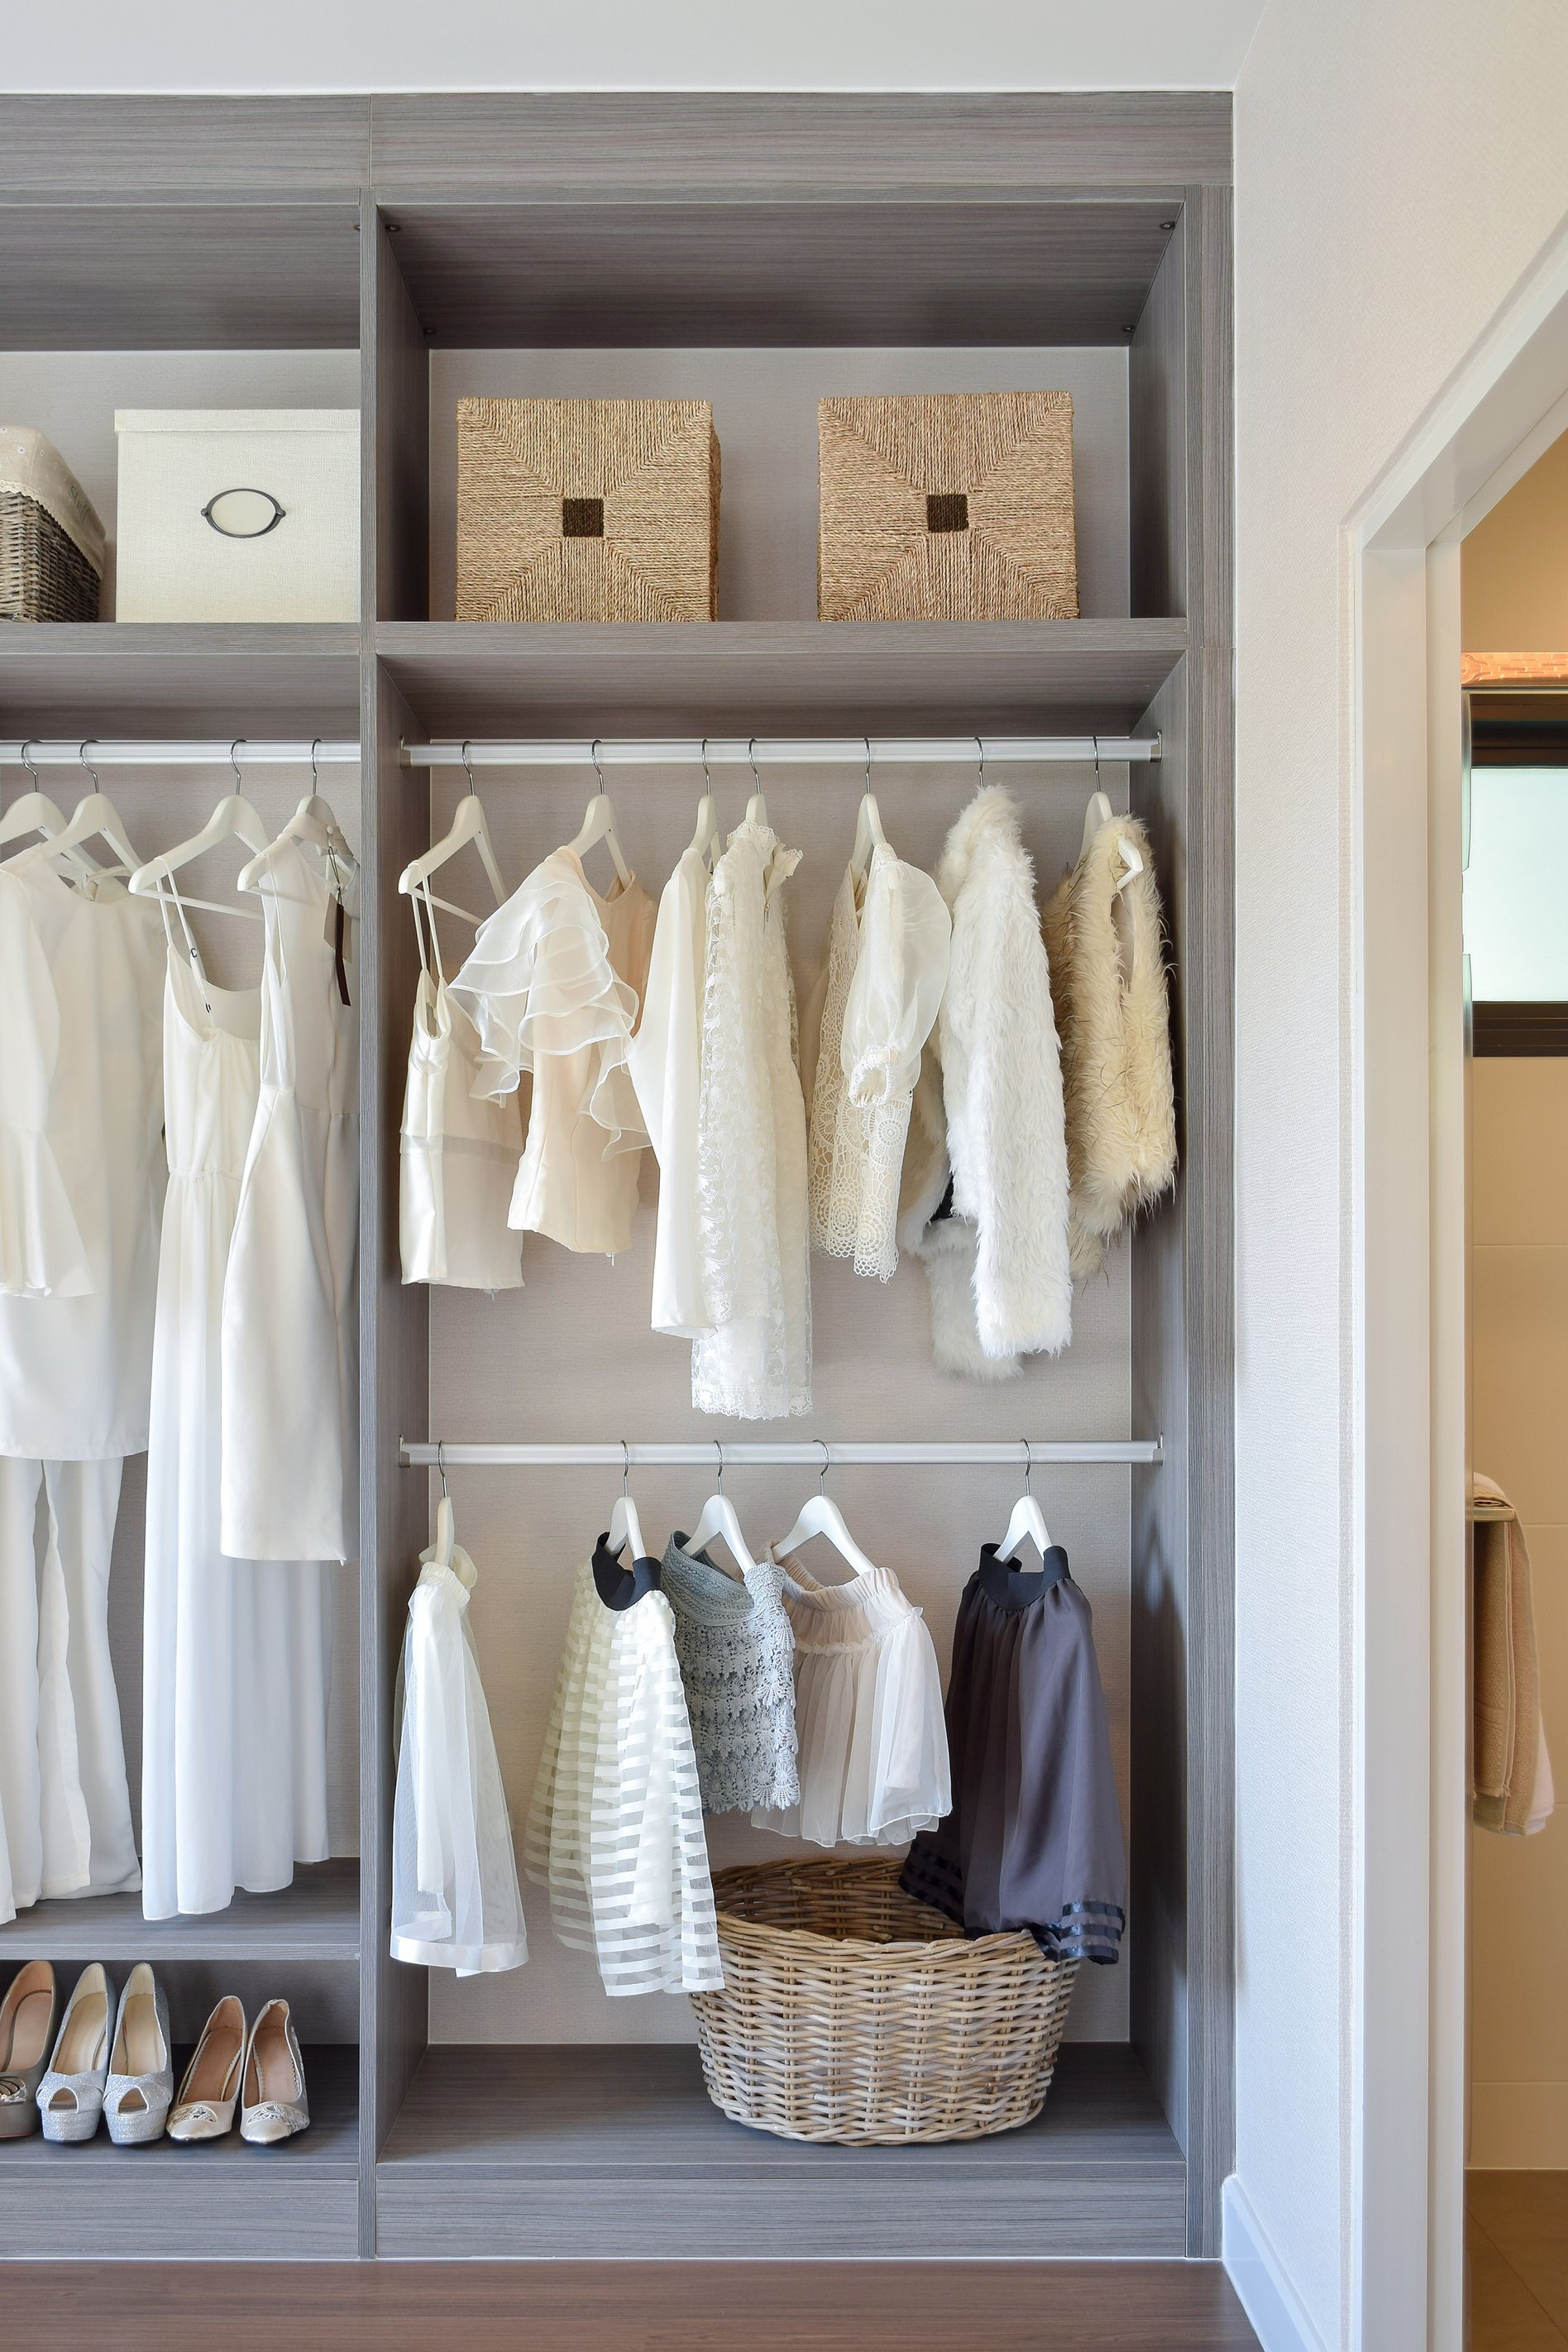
[0,1861,360,1957]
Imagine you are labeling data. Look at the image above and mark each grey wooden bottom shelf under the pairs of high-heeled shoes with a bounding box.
[0,2042,360,2260]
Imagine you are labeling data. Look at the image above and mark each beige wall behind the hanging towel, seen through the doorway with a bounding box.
[1467,1068,1568,2168]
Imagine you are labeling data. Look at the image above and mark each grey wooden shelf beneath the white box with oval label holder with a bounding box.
[0,621,360,741]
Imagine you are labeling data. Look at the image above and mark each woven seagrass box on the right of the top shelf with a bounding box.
[815,393,1079,621]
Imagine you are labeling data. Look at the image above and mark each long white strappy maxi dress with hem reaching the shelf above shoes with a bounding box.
[141,941,332,1919]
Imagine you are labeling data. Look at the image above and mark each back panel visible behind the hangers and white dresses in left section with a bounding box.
[0,757,360,1872]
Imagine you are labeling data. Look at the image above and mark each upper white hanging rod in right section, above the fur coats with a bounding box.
[402,736,1159,767]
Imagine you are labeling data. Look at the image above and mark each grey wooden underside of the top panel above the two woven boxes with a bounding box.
[390,198,1178,351]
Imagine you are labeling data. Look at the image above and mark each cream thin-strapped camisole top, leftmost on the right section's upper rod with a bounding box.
[397,889,522,1291]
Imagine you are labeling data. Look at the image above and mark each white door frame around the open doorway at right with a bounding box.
[1340,211,1568,2352]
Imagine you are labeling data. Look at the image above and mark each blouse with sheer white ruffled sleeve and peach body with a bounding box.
[452,849,653,1256]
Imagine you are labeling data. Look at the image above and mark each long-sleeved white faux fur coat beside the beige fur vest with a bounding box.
[898,786,1072,1380]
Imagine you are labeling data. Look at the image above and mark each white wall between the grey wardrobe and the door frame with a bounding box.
[1236,0,1568,2352]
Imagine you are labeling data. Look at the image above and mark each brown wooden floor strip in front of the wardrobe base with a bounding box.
[0,2263,1258,2352]
